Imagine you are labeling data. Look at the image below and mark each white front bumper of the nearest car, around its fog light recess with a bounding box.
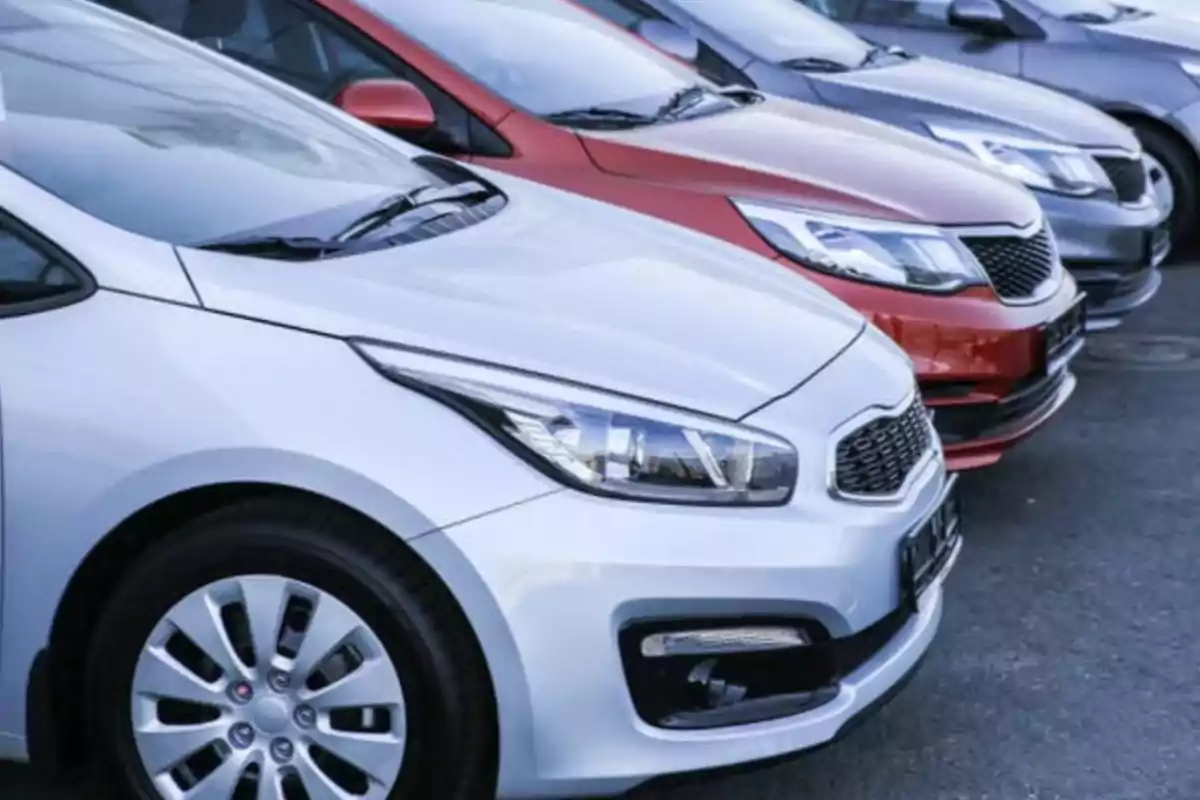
[432,468,958,798]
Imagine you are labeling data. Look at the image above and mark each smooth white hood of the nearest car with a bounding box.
[180,170,873,419]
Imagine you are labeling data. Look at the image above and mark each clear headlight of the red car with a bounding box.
[733,198,988,293]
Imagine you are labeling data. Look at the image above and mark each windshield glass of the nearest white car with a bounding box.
[0,0,436,245]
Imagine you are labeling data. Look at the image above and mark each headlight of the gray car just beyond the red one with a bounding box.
[929,125,1112,197]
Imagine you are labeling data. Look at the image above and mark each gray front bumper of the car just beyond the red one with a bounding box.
[1037,192,1171,330]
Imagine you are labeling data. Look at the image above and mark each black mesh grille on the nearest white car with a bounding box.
[835,398,931,497]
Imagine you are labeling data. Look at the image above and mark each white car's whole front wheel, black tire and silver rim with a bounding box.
[88,503,494,800]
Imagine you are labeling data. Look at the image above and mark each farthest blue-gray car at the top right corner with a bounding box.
[797,0,1200,250]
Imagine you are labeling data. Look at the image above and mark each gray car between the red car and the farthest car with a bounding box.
[578,0,1170,330]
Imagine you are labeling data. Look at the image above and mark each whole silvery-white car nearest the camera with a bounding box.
[0,0,961,800]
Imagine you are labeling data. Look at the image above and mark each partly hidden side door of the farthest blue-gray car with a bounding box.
[825,0,1024,76]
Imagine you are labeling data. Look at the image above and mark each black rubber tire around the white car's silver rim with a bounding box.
[85,500,497,800]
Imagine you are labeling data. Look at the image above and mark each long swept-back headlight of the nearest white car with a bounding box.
[354,342,798,506]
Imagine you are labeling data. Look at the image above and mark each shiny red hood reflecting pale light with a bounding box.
[580,98,1039,225]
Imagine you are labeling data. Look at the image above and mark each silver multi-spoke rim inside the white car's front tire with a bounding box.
[131,575,406,800]
